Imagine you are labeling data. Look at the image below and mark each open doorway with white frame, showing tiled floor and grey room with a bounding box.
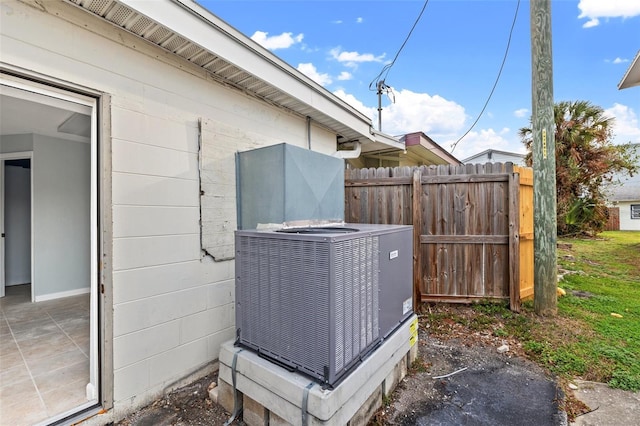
[0,76,99,425]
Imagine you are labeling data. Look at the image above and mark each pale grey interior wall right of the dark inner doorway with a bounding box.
[32,135,91,301]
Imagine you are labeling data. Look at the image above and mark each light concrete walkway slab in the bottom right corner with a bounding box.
[571,381,640,426]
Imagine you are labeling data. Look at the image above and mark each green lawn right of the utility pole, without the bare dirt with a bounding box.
[543,232,640,391]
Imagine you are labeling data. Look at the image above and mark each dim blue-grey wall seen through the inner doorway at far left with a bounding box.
[4,164,31,286]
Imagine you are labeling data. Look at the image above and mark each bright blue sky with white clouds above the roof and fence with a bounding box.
[198,0,640,159]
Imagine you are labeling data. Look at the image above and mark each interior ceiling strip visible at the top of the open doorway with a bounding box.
[0,94,91,142]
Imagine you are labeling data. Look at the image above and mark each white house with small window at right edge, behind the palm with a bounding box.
[606,143,640,231]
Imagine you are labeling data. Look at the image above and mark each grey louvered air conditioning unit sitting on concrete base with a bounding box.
[235,224,413,387]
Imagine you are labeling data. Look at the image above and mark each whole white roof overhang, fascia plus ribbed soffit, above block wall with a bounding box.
[70,0,400,150]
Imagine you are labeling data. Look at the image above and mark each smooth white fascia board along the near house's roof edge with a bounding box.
[67,0,375,142]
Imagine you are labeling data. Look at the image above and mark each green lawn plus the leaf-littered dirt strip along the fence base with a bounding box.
[425,232,640,391]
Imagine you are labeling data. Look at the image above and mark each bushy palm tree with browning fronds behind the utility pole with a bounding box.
[519,101,636,235]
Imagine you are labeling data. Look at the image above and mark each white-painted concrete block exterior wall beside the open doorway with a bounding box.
[0,1,336,411]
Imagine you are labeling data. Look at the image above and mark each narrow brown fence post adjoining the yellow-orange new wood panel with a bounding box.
[509,172,520,312]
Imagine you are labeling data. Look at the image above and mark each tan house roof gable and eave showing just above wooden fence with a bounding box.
[349,132,461,168]
